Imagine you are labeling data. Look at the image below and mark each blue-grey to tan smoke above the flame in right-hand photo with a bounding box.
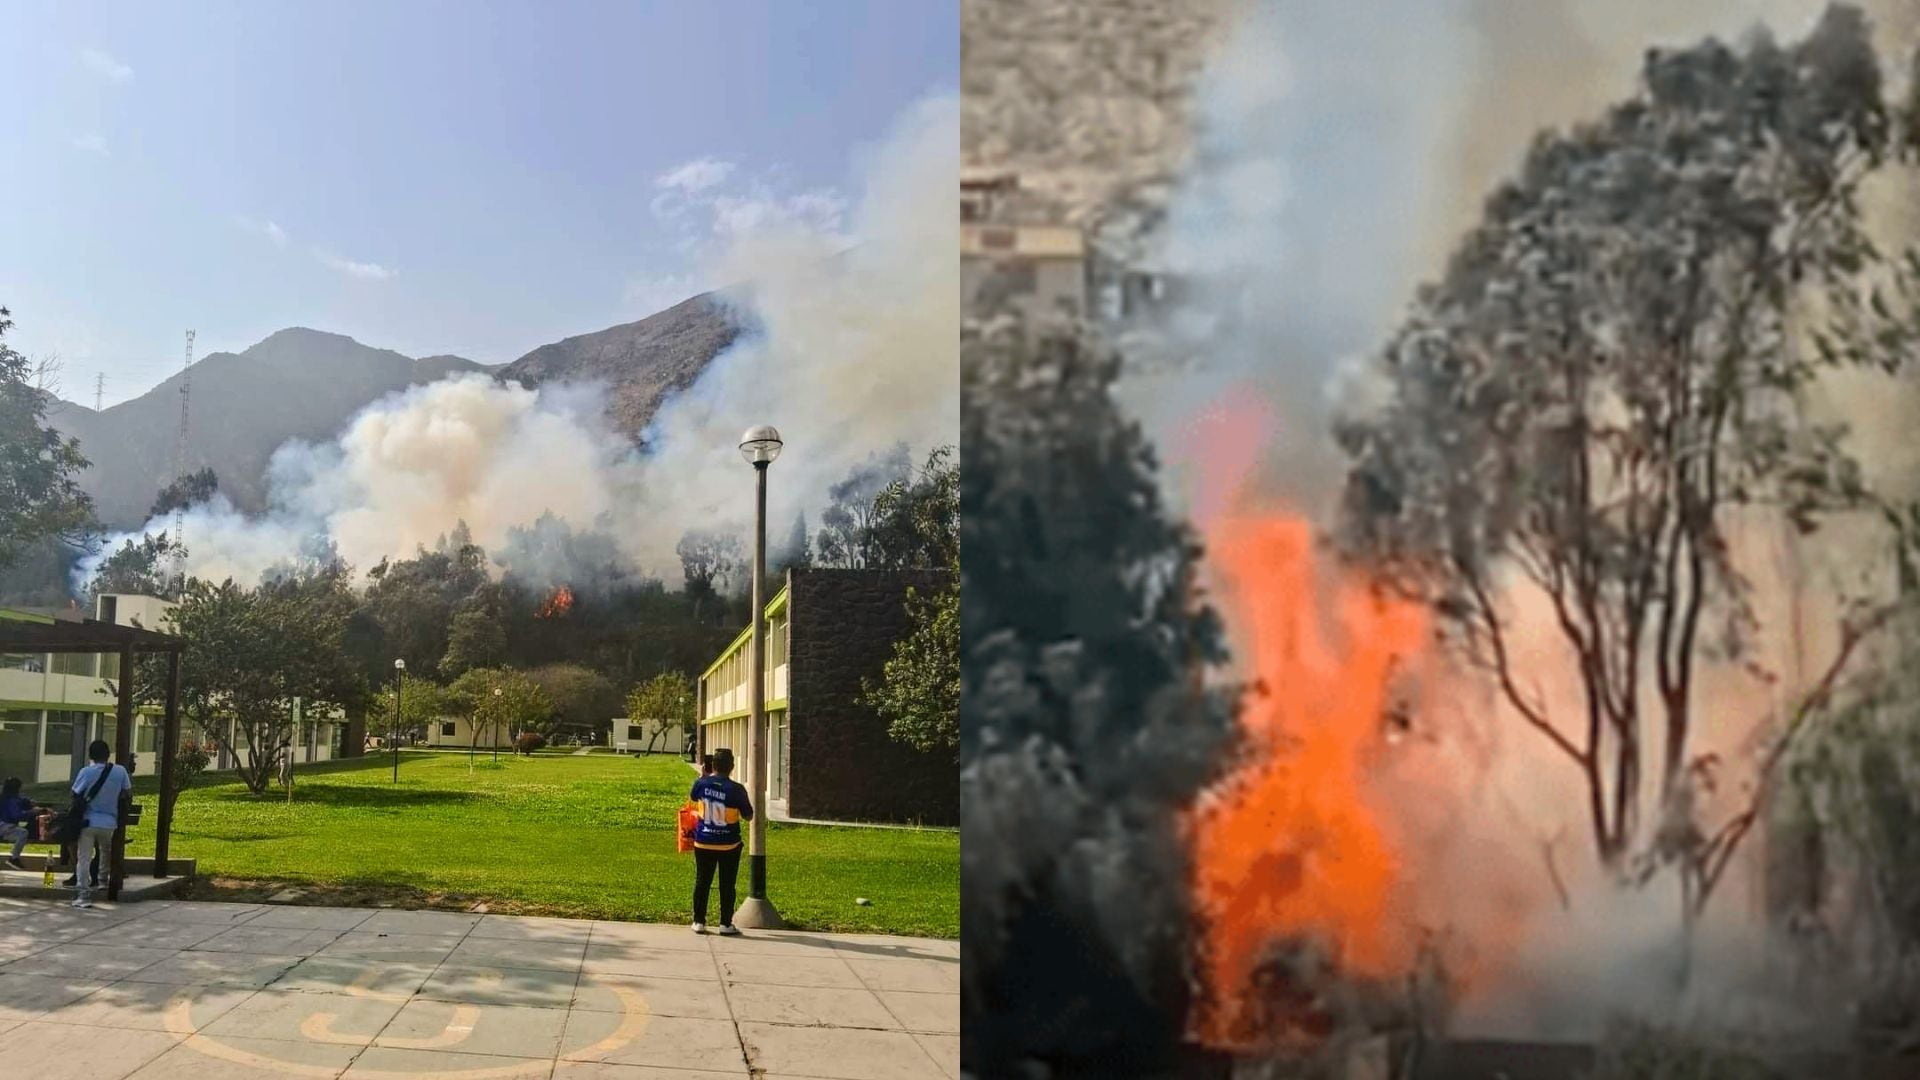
[1123,0,1920,509]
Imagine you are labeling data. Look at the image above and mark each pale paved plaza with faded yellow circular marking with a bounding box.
[0,897,960,1080]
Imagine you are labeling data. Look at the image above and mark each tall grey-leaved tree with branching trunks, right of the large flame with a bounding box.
[1338,8,1901,911]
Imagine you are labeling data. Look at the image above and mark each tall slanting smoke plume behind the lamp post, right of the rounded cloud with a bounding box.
[624,96,960,565]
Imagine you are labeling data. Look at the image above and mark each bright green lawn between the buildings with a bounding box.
[46,751,960,938]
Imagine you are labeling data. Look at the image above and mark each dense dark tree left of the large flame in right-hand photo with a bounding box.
[960,323,1231,1076]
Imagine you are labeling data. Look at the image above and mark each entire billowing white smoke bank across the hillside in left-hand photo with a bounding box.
[81,96,960,584]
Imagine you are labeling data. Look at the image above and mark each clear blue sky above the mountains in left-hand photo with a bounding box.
[0,0,960,405]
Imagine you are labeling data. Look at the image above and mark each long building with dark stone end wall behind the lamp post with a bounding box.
[697,569,960,824]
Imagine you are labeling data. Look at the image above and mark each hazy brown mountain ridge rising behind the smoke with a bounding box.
[48,296,741,528]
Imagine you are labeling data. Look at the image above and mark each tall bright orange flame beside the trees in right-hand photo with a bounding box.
[1185,399,1428,1049]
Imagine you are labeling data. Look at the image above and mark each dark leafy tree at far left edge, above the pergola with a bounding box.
[0,307,94,569]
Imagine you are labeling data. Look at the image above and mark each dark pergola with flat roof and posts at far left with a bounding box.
[0,619,186,899]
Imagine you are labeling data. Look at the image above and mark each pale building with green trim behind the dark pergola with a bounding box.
[0,594,342,784]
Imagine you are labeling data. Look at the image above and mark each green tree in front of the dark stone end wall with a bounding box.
[862,572,960,757]
